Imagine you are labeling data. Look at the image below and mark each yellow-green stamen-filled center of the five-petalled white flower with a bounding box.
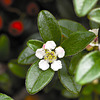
[44,51,57,63]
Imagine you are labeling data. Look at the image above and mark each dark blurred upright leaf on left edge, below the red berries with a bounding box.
[0,34,10,60]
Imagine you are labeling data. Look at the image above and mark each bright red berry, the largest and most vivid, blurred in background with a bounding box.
[8,20,24,36]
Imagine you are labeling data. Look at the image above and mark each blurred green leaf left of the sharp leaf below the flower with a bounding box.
[8,60,29,78]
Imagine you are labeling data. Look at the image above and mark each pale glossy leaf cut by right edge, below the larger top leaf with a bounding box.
[88,8,100,23]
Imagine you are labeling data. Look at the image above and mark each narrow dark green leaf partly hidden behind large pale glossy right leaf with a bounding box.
[69,52,85,75]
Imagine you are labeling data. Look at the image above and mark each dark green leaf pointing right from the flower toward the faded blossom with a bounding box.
[61,31,95,56]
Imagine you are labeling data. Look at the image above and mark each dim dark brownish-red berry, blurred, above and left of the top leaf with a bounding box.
[27,2,39,16]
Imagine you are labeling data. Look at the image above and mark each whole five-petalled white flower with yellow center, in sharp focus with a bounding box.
[35,41,65,71]
